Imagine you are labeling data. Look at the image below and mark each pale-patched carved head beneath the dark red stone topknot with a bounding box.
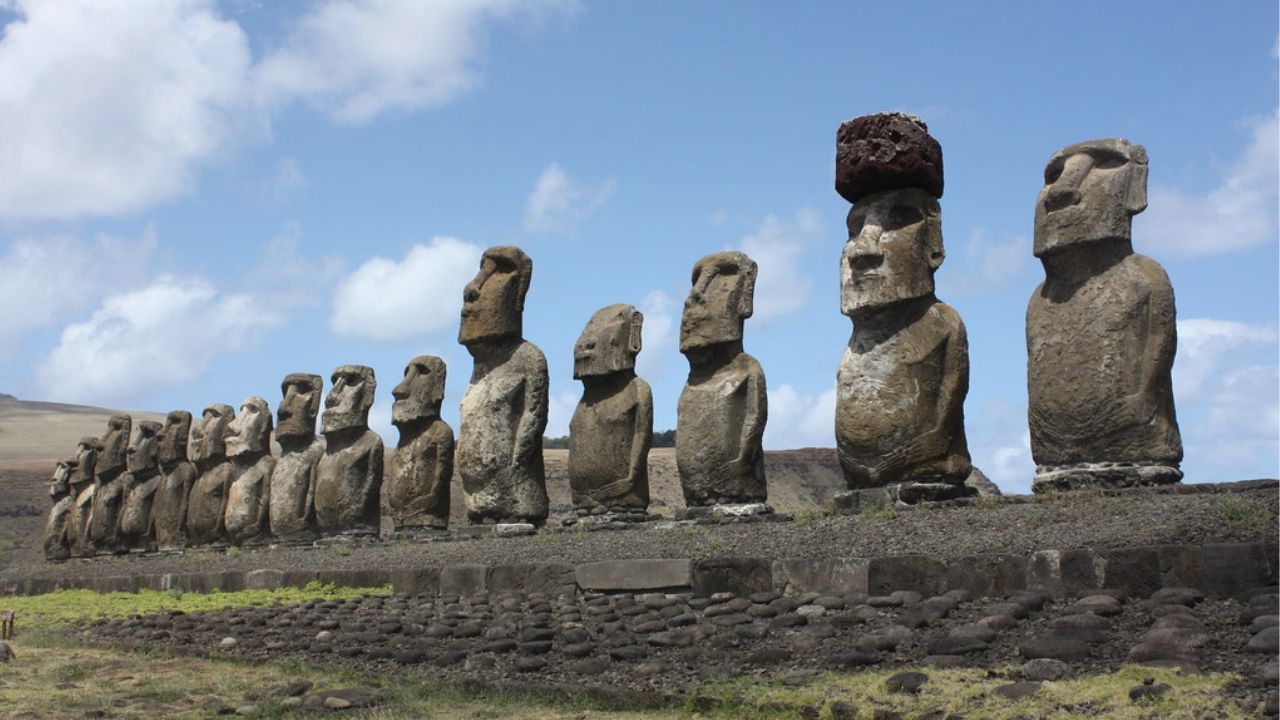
[840,188,943,316]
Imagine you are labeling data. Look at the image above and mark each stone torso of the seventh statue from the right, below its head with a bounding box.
[315,429,383,534]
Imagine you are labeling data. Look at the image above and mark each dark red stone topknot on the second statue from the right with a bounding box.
[836,113,942,202]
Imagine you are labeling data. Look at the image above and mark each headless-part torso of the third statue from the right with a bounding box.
[676,352,767,505]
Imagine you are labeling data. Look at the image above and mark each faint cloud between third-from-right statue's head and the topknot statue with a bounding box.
[740,208,822,324]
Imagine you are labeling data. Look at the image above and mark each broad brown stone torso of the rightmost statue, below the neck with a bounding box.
[1027,255,1183,465]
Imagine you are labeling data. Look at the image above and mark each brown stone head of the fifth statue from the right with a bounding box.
[458,246,534,347]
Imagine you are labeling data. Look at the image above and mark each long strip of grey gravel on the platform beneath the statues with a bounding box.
[3,480,1280,578]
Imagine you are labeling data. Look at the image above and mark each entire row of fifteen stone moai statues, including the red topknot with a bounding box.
[46,113,1181,557]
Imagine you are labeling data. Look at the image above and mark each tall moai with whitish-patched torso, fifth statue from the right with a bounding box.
[457,247,550,525]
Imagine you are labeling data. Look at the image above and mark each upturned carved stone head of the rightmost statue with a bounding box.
[1034,138,1147,258]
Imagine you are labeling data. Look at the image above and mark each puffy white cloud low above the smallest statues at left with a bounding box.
[37,275,282,406]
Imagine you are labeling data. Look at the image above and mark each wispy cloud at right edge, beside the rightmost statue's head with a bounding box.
[1134,114,1280,258]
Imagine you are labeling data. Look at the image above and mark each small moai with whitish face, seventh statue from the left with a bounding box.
[223,397,275,544]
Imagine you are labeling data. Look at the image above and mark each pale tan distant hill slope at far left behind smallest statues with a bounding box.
[0,393,165,470]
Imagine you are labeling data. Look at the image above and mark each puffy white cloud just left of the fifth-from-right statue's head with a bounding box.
[329,236,481,342]
